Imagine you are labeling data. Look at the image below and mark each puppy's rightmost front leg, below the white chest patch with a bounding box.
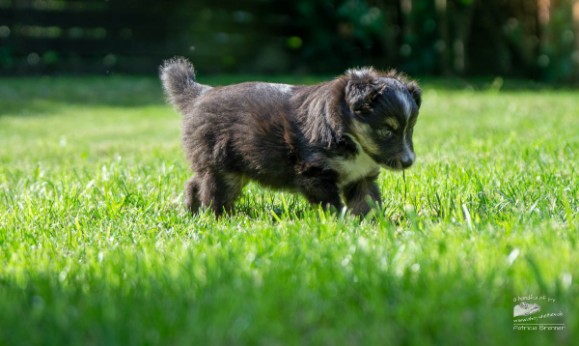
[343,177,381,216]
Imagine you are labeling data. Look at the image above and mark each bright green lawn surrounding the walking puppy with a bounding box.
[0,77,579,345]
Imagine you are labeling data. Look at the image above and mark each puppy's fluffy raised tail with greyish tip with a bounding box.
[159,58,211,113]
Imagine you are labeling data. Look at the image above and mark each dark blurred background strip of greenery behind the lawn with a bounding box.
[0,0,579,83]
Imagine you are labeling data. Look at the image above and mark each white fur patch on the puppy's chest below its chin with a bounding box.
[330,136,380,188]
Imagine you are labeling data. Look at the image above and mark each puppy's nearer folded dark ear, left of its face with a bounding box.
[345,68,385,113]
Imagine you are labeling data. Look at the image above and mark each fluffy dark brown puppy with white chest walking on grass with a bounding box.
[160,58,421,216]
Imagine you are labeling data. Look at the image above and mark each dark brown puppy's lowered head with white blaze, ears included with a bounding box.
[344,68,421,170]
